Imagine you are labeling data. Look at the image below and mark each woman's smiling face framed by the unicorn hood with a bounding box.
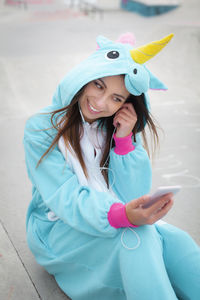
[79,75,129,123]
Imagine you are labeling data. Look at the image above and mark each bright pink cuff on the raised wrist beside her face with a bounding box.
[114,132,135,155]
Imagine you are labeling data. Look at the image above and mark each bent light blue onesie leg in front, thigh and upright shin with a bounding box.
[28,219,180,300]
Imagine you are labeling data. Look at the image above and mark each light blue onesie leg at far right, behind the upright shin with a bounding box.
[156,224,200,300]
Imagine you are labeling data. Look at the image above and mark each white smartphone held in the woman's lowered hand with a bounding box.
[143,185,181,208]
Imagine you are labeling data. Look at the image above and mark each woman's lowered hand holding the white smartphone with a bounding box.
[126,193,173,226]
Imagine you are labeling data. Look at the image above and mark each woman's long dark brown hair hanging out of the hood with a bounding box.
[37,87,158,185]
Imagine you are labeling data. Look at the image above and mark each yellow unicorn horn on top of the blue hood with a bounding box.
[130,33,174,64]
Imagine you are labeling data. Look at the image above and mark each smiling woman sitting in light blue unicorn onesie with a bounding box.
[24,35,200,300]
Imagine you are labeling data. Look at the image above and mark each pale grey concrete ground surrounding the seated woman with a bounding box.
[0,0,200,300]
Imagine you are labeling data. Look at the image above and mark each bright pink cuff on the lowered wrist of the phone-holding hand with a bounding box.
[108,203,138,228]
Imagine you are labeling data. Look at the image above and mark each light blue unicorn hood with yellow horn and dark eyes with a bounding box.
[53,34,173,109]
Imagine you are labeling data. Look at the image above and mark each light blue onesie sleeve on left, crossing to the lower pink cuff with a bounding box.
[24,116,120,237]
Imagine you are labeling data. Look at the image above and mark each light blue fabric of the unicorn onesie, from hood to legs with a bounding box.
[24,37,200,300]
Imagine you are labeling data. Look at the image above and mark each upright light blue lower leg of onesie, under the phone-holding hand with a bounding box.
[120,226,177,300]
